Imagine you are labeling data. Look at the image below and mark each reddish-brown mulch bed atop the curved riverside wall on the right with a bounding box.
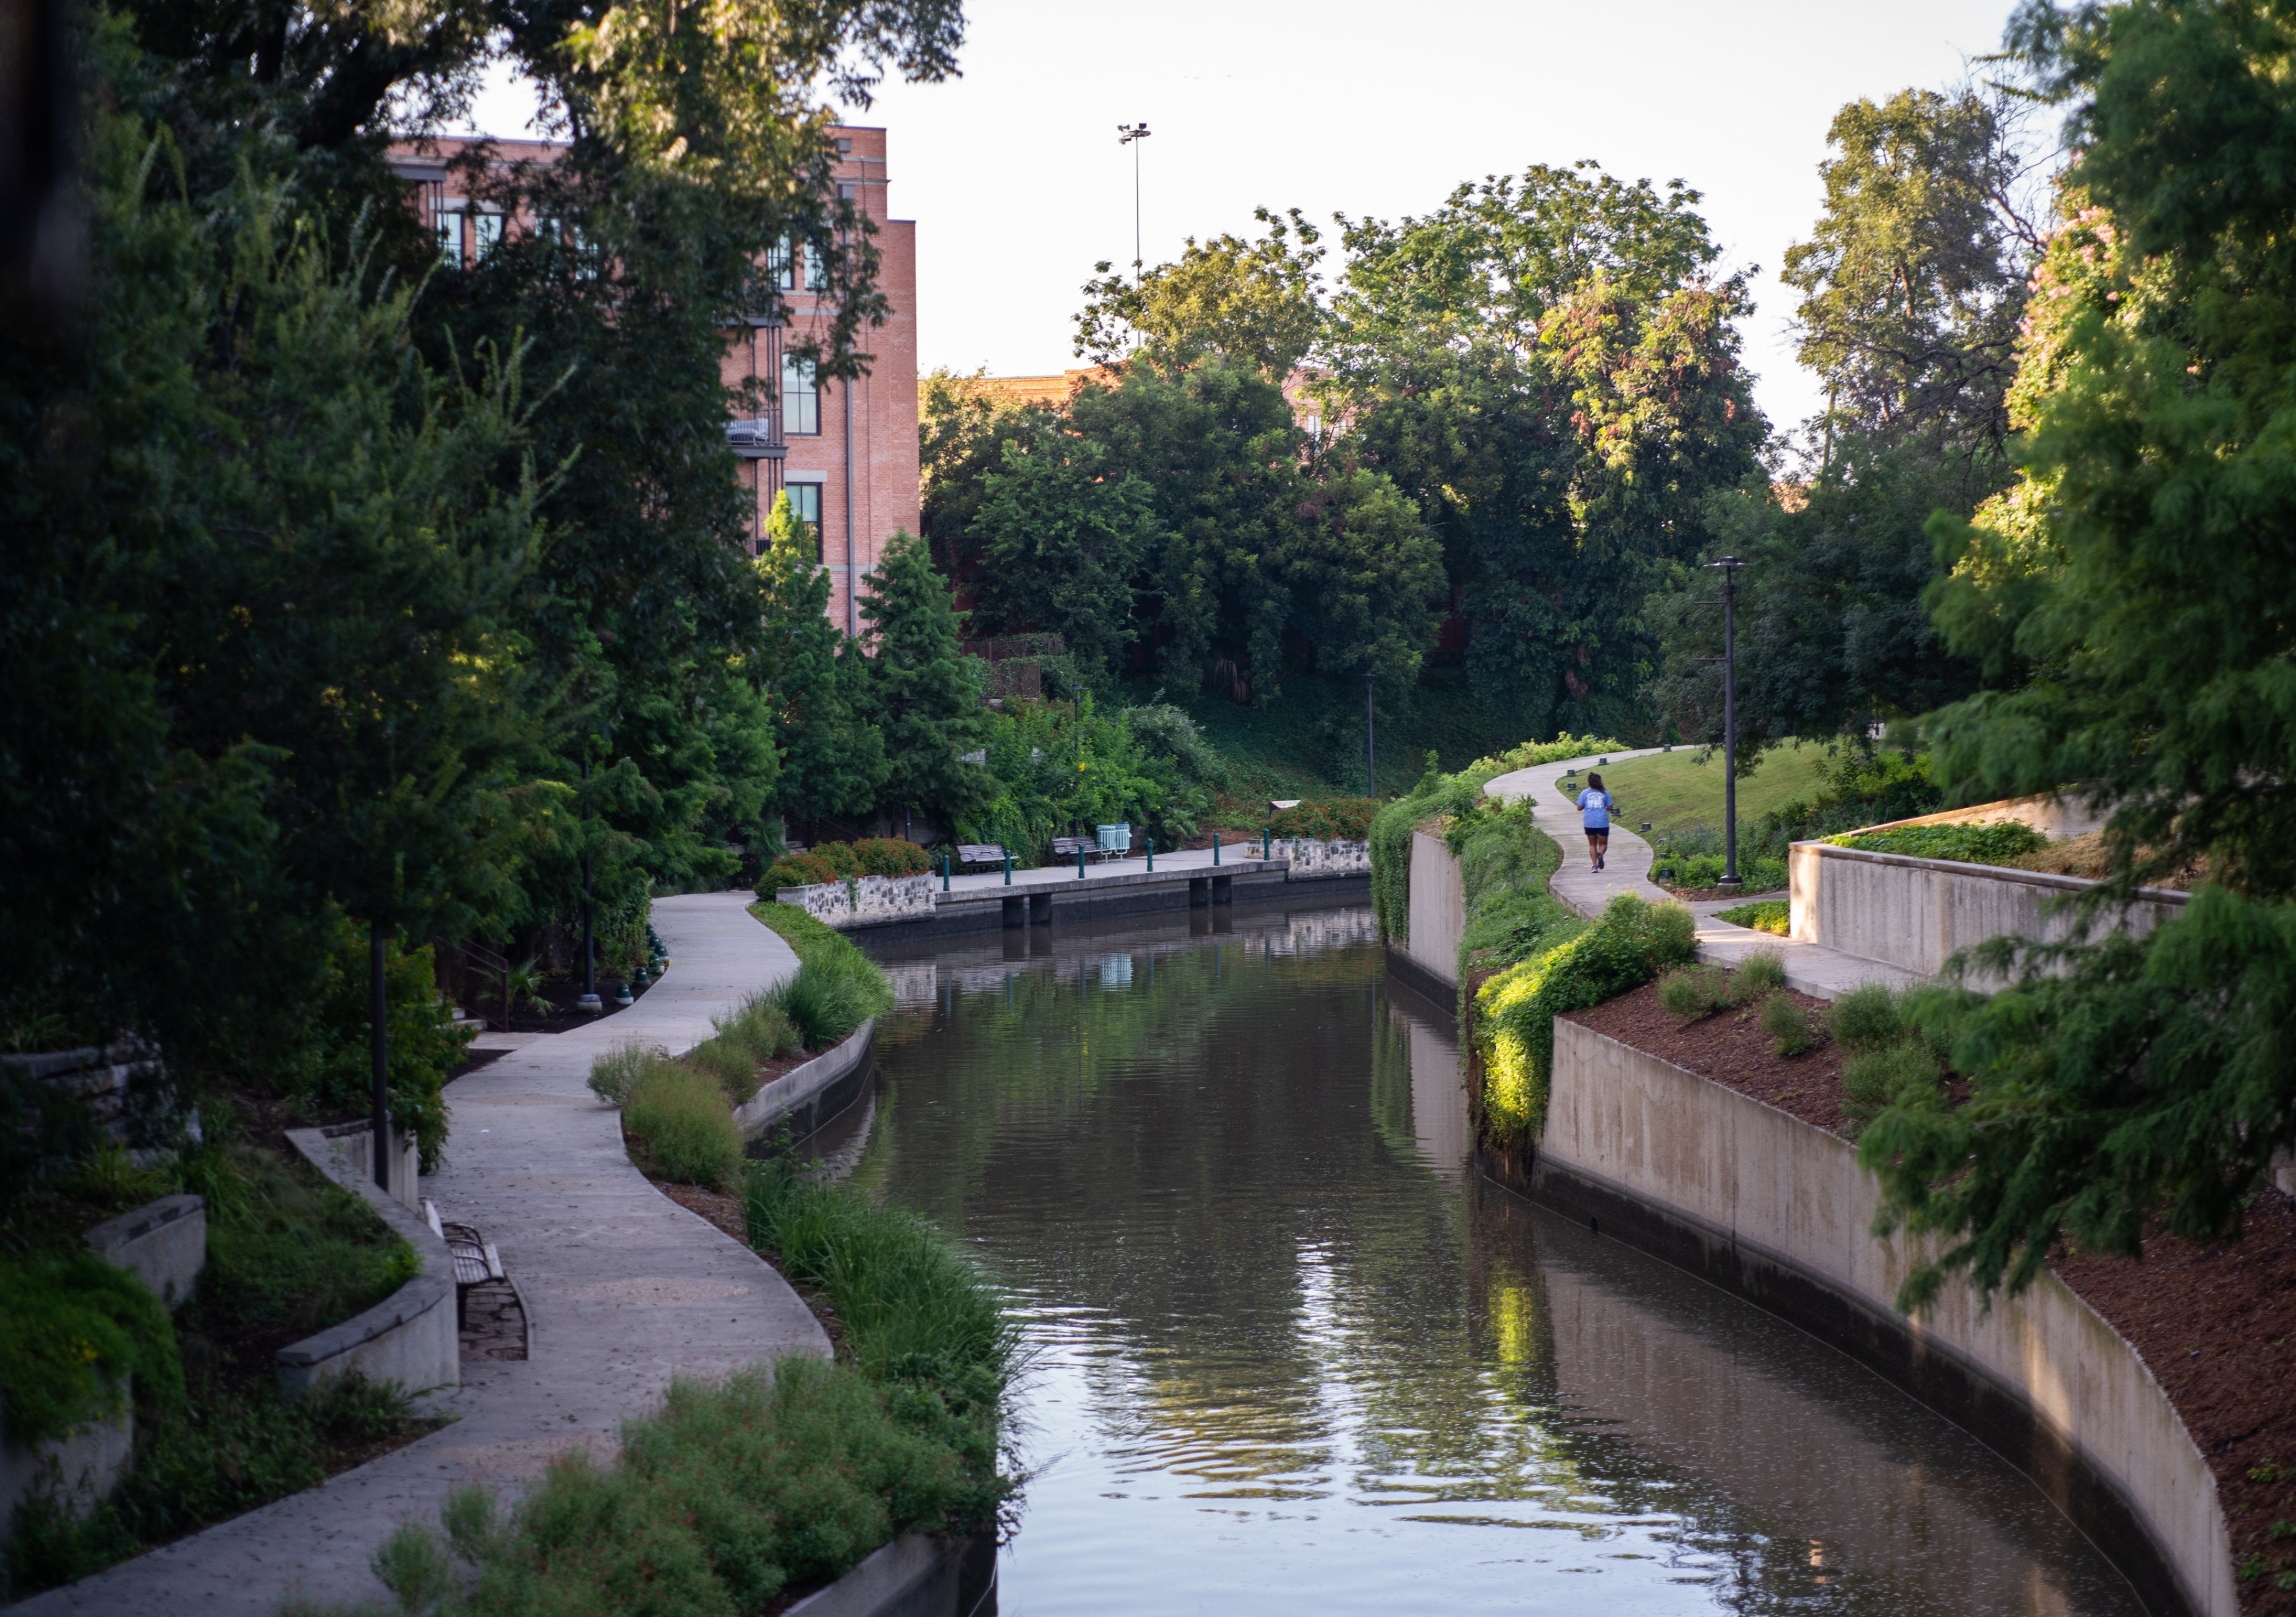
[1568,983,2296,1617]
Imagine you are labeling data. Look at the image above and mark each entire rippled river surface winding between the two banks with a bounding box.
[854,910,2138,1617]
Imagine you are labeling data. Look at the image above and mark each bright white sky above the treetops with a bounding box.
[457,0,2009,445]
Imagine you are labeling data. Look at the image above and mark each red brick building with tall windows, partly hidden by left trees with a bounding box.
[393,126,918,631]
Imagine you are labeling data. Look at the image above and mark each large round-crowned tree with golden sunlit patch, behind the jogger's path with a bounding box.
[1325,165,1763,732]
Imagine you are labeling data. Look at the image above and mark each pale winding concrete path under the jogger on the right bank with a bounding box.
[1483,746,1913,999]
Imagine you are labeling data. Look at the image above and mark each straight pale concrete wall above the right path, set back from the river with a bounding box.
[1786,843,2186,976]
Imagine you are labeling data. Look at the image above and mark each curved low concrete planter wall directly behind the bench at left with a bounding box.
[278,1128,461,1394]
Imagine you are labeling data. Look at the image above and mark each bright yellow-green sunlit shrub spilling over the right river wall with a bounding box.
[1474,896,1697,1144]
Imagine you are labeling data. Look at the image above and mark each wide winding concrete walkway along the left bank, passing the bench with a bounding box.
[11,894,829,1617]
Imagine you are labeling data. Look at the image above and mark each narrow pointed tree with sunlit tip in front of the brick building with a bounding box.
[758,494,886,825]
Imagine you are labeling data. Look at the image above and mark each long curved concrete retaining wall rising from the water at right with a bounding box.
[1515,1022,2239,1617]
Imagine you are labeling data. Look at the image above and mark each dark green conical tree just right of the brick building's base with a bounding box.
[861,533,992,832]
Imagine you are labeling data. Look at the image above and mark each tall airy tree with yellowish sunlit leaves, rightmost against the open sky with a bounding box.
[1782,90,2041,491]
